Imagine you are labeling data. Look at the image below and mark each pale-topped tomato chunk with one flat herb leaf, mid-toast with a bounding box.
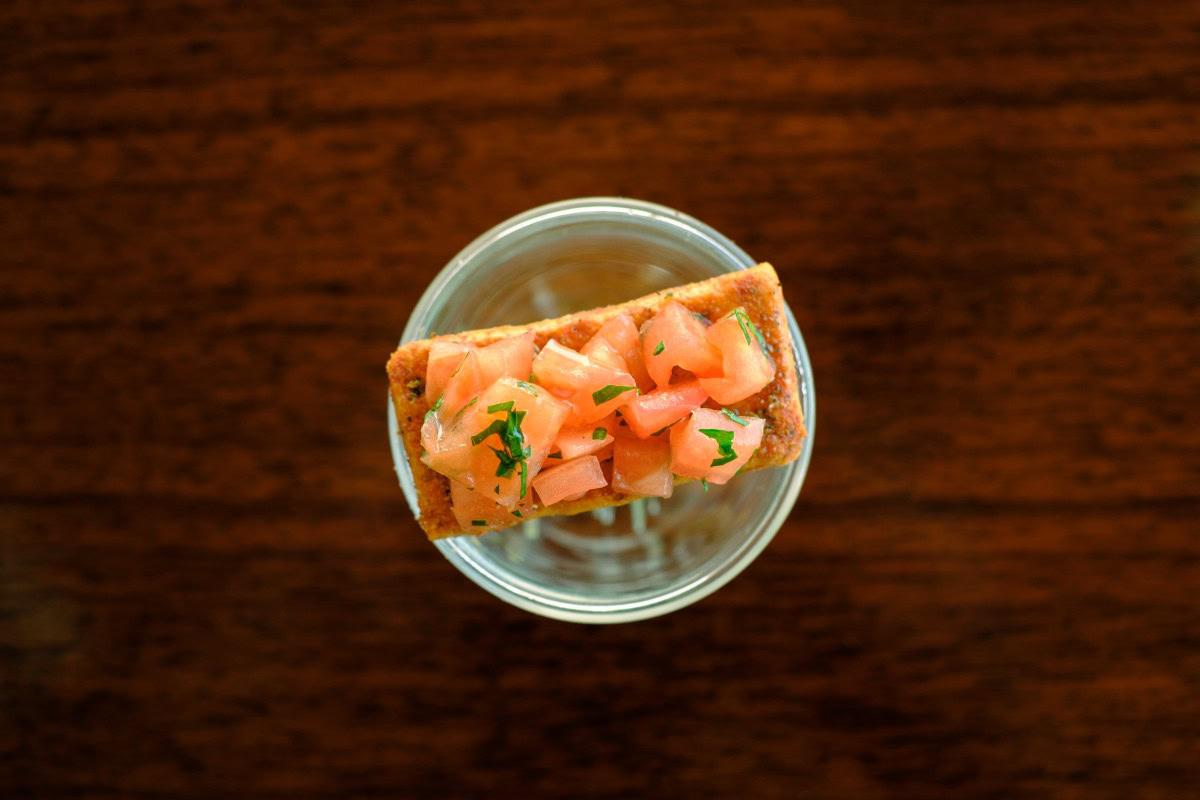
[533,339,637,425]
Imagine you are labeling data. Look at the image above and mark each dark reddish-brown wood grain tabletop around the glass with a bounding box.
[0,0,1200,799]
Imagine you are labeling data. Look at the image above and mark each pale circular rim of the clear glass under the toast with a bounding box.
[388,197,816,624]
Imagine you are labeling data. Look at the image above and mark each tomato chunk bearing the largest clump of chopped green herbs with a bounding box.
[463,378,570,509]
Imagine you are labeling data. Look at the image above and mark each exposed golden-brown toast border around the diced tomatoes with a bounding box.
[388,264,805,539]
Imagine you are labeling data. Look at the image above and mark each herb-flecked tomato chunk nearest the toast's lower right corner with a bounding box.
[671,408,766,483]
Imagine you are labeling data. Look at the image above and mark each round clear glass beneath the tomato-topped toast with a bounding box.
[388,198,816,622]
